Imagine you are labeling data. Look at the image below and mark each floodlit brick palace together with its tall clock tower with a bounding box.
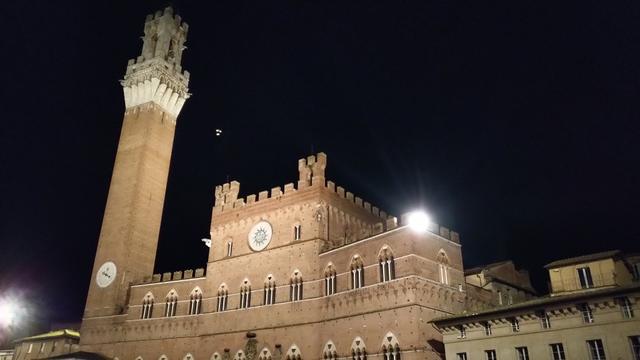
[80,8,528,360]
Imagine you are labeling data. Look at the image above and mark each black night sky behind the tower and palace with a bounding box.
[0,0,640,342]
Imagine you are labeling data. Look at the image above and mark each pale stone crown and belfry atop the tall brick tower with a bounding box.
[121,7,191,121]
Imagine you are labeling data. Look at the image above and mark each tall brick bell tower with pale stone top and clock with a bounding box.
[84,8,189,319]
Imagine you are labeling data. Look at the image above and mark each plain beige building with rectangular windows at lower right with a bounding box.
[433,251,640,360]
